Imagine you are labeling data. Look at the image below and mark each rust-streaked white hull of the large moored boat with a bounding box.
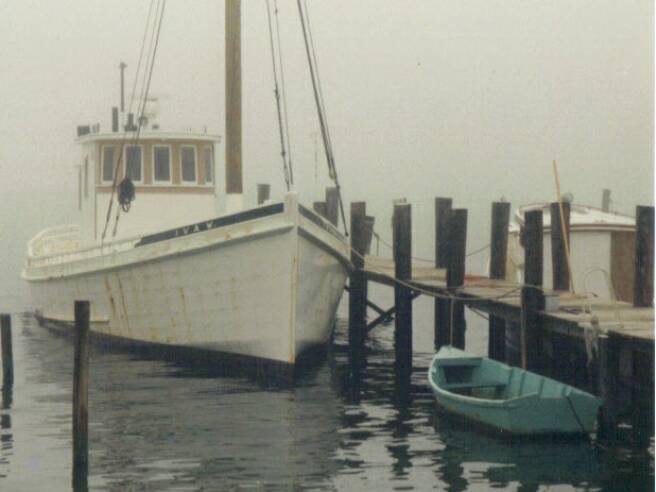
[25,195,348,364]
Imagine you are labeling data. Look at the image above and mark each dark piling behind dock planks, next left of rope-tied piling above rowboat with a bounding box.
[487,202,510,362]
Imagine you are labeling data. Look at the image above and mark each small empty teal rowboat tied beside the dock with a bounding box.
[428,347,601,435]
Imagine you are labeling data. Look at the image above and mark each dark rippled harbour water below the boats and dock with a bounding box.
[0,317,654,491]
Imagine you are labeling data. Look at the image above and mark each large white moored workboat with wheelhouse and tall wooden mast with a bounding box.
[23,0,350,365]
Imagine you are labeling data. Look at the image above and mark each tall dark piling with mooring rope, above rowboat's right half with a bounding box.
[521,210,544,373]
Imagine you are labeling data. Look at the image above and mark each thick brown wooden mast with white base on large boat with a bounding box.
[225,0,243,212]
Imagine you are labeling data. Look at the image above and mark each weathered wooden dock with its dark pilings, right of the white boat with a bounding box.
[336,198,654,432]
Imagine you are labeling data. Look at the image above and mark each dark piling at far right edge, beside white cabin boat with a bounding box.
[633,206,654,307]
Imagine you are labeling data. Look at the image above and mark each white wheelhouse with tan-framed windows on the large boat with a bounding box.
[77,130,220,245]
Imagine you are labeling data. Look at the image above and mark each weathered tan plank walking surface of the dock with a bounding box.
[364,256,654,351]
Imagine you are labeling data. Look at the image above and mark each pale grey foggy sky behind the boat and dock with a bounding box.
[0,0,654,310]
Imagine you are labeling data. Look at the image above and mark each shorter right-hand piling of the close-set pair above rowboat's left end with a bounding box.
[446,208,467,349]
